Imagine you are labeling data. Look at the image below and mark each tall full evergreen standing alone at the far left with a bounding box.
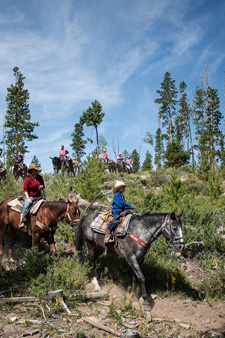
[4,67,39,165]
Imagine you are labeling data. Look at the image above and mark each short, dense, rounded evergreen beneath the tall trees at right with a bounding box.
[164,141,190,168]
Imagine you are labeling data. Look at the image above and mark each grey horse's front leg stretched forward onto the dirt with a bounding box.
[127,255,154,310]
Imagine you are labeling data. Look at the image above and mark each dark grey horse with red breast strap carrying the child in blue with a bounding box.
[76,212,184,309]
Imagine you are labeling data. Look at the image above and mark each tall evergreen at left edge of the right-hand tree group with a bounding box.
[155,72,177,142]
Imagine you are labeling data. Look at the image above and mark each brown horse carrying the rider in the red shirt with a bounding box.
[0,194,80,260]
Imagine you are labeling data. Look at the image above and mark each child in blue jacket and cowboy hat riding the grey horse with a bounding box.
[104,181,133,243]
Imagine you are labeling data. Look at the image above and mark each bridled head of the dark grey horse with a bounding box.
[162,212,184,252]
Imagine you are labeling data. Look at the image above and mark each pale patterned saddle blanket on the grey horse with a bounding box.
[91,213,133,237]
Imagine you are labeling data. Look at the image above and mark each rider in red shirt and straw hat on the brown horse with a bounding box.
[19,163,45,228]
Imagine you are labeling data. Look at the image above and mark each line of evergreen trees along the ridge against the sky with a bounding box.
[0,61,225,180]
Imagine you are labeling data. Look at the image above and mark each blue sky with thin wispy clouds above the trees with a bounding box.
[0,0,225,172]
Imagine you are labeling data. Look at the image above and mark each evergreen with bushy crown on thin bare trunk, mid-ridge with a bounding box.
[80,100,105,154]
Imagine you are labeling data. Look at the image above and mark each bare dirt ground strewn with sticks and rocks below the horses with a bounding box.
[0,260,225,338]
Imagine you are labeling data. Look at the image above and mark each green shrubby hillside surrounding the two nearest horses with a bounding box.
[0,161,225,298]
